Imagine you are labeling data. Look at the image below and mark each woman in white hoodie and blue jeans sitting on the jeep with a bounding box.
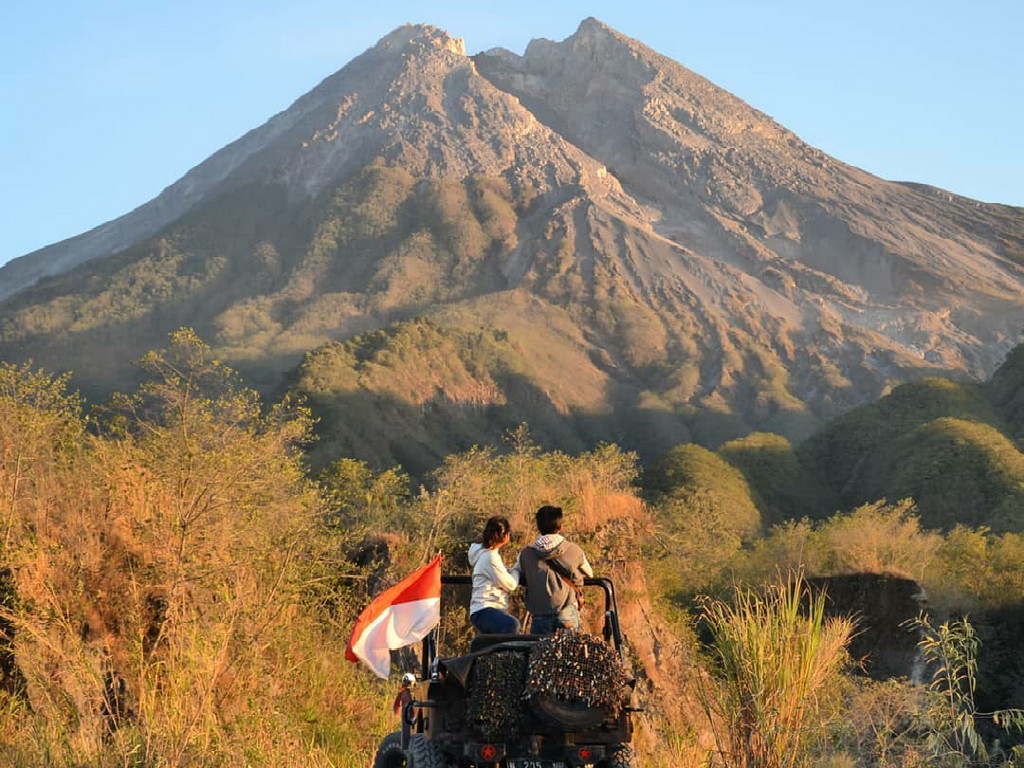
[469,517,519,635]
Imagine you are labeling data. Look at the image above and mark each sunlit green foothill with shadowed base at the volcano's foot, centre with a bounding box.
[290,291,704,476]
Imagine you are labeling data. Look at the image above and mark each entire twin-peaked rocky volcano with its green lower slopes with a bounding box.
[0,19,1024,467]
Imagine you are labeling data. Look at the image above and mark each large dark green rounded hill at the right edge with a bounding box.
[797,354,1024,530]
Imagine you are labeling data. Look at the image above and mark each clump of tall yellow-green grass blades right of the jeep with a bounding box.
[698,575,853,768]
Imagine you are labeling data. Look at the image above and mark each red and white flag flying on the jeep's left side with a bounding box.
[345,555,441,679]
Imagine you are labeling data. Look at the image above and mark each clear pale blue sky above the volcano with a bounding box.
[0,0,1024,263]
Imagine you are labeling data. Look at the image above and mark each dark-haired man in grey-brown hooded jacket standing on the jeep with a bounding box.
[519,506,594,635]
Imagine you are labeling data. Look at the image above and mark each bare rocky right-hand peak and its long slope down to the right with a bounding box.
[476,19,1024,374]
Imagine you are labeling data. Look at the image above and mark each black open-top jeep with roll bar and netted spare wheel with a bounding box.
[374,575,636,768]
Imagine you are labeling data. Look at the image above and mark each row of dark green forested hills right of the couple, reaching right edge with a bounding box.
[645,345,1024,535]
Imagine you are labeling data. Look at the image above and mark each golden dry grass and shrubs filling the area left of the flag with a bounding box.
[0,356,390,768]
